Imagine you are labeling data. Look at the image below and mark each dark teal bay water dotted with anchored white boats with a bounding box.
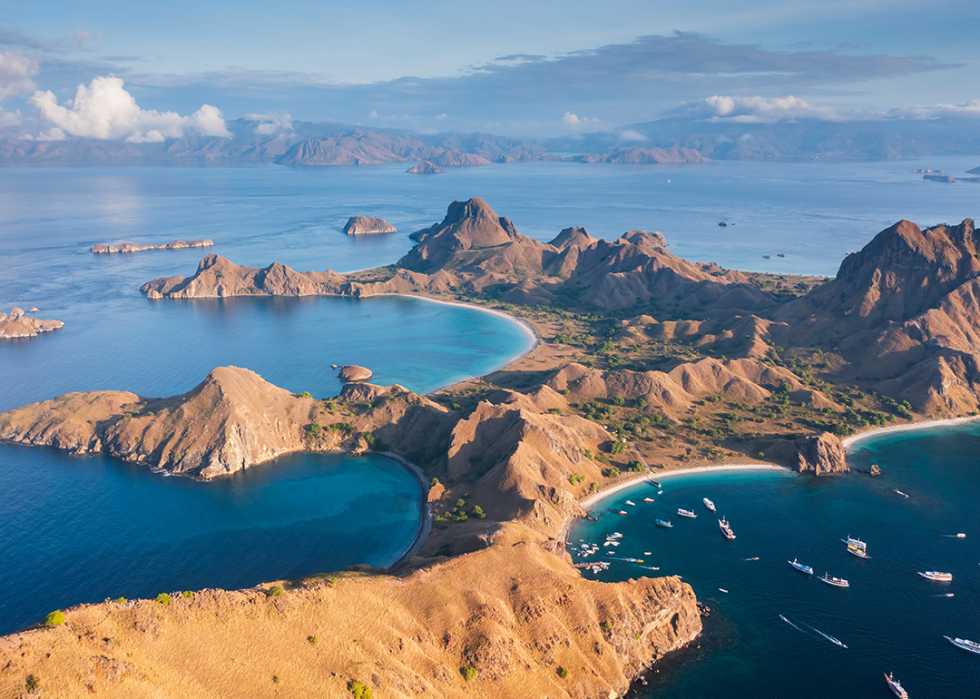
[570,423,980,699]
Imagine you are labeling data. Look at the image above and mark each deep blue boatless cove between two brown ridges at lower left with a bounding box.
[0,445,422,635]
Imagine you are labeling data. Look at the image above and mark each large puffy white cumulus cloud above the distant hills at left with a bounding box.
[31,75,231,143]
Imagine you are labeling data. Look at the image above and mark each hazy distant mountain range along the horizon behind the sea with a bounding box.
[0,118,980,167]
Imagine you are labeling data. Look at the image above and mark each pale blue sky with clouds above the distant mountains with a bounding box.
[0,0,980,142]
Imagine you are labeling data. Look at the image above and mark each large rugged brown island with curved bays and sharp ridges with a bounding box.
[0,199,980,697]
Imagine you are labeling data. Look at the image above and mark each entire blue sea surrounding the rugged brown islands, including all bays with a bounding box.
[0,157,980,697]
